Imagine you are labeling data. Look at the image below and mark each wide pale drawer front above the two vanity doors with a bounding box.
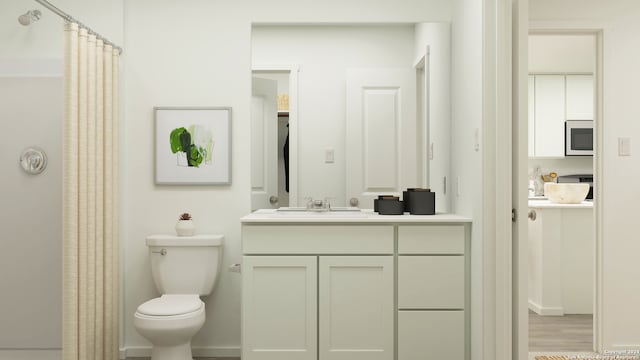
[242,225,393,254]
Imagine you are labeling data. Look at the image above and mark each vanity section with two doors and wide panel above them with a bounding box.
[242,225,395,360]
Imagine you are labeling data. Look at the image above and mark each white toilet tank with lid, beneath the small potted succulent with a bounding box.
[146,234,224,296]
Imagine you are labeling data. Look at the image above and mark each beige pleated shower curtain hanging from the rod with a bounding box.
[62,23,119,360]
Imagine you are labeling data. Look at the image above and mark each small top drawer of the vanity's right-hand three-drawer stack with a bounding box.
[398,225,464,254]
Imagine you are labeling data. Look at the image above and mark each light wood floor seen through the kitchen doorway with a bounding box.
[529,311,593,352]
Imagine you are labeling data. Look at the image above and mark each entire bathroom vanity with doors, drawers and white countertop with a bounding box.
[242,213,470,360]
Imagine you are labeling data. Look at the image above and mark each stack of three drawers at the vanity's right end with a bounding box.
[398,225,467,360]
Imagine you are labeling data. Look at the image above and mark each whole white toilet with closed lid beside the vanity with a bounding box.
[134,235,223,360]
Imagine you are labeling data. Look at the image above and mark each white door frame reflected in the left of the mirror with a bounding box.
[251,64,300,206]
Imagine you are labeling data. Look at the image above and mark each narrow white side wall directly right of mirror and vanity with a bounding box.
[450,0,482,359]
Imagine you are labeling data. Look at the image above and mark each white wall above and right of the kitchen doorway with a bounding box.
[530,0,640,350]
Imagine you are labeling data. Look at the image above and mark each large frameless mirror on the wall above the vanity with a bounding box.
[251,23,450,211]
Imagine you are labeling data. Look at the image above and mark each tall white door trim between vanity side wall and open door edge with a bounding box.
[490,0,513,360]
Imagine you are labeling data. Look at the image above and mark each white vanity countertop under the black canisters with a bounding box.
[240,209,471,224]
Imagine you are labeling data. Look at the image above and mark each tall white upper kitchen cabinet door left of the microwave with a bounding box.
[535,75,565,158]
